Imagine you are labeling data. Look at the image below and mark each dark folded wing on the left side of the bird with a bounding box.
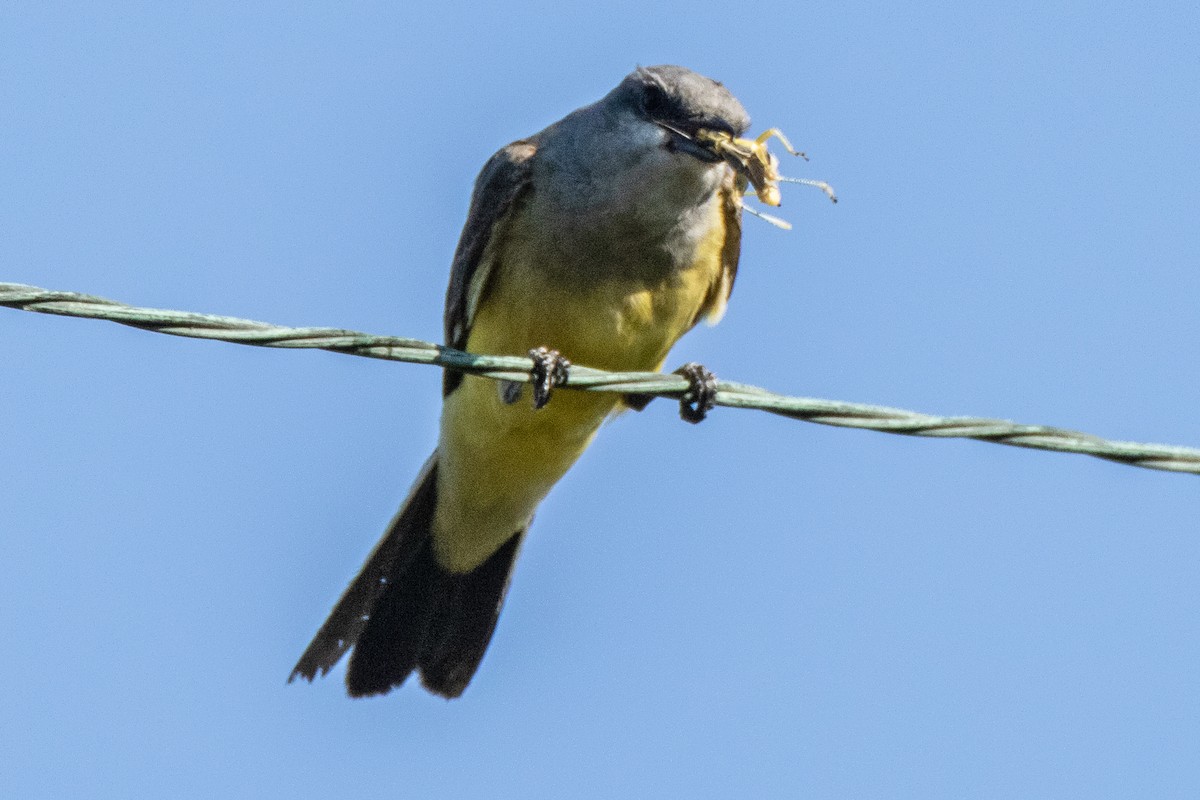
[442,139,538,395]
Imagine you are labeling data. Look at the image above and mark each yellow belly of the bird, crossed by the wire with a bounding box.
[433,206,724,572]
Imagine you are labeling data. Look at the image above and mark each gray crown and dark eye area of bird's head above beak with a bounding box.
[611,65,750,144]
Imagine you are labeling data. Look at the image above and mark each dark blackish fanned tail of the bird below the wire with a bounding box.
[288,452,524,698]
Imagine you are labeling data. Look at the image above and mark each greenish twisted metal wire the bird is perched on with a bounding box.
[0,283,1200,474]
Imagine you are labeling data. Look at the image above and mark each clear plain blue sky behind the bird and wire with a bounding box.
[0,0,1200,799]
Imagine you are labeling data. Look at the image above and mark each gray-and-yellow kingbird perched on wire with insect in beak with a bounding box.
[289,66,778,698]
